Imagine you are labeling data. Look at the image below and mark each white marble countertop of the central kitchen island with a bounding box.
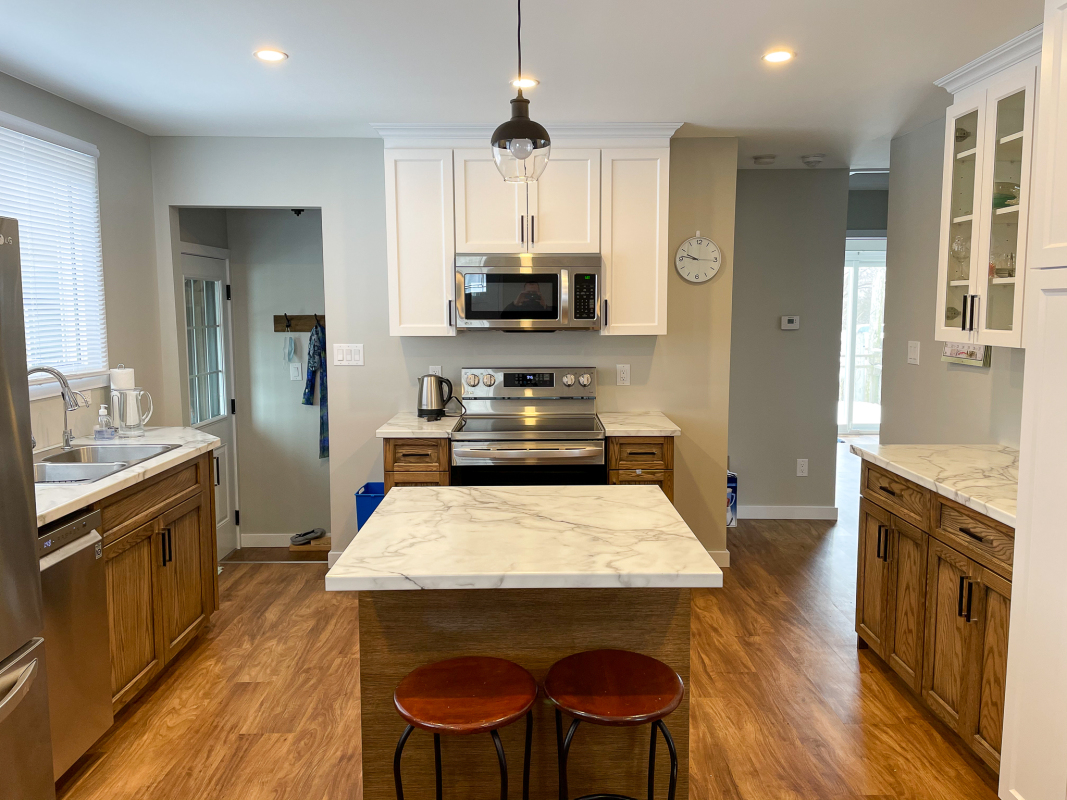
[327,485,722,592]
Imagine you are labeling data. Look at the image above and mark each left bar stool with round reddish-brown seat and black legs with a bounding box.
[393,656,537,800]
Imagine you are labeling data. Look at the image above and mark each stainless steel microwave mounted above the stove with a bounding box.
[456,253,604,331]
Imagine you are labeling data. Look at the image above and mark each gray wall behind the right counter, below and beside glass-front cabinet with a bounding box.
[881,121,1024,447]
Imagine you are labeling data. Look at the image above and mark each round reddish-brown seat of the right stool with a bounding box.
[544,650,684,725]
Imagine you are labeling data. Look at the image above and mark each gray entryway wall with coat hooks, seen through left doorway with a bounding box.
[225,210,330,535]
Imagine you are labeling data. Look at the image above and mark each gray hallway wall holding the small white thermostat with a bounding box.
[730,170,848,515]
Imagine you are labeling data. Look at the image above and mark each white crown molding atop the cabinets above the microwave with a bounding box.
[370,123,682,147]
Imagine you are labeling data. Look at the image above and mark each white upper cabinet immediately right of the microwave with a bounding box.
[601,147,670,336]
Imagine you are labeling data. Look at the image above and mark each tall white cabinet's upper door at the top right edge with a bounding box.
[1029,0,1067,269]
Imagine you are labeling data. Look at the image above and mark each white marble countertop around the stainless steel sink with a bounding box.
[34,428,221,527]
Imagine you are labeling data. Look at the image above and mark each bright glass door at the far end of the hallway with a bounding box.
[838,239,886,433]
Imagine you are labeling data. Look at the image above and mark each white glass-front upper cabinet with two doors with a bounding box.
[936,45,1040,348]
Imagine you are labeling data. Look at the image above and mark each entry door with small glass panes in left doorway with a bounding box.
[181,244,240,558]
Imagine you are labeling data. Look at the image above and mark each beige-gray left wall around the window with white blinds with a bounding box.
[0,74,162,447]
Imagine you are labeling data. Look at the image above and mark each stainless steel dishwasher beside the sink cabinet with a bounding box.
[37,511,114,780]
